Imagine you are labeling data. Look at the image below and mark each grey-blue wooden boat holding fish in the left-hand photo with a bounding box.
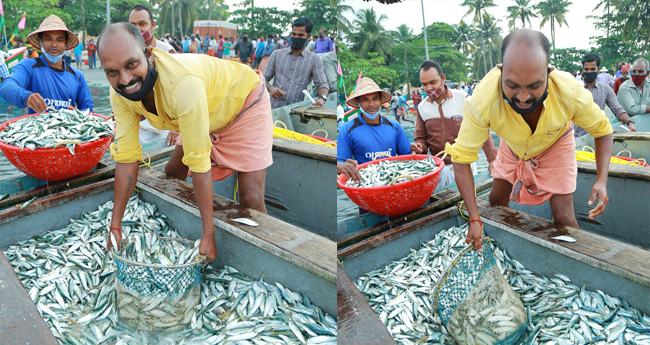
[0,169,336,344]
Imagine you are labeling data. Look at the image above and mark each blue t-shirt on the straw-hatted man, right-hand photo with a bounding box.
[336,116,411,164]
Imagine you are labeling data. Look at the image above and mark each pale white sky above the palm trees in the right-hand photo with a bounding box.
[344,0,604,49]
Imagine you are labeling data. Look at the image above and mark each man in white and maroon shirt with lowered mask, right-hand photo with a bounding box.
[411,60,497,188]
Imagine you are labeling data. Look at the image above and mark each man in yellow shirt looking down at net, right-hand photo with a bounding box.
[445,30,612,250]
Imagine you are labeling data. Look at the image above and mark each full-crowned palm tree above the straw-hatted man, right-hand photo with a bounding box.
[350,8,394,59]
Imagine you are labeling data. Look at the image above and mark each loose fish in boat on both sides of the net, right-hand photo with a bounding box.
[357,226,650,345]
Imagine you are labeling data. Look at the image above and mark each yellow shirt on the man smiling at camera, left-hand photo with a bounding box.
[110,48,260,173]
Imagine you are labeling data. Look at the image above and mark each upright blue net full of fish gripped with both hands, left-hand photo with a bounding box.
[111,232,206,329]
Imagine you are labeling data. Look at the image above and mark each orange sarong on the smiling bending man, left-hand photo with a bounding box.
[176,72,273,181]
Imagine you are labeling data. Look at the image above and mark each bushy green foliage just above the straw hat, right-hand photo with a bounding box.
[337,41,400,95]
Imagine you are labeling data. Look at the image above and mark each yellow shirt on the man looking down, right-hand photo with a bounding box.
[445,67,612,164]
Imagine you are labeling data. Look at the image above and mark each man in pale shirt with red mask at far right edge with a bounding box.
[617,58,650,116]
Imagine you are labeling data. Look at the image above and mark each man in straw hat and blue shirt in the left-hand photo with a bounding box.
[0,15,94,113]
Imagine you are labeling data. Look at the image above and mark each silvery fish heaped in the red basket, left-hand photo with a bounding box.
[0,109,115,154]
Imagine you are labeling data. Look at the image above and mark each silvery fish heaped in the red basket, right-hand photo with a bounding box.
[346,157,437,187]
